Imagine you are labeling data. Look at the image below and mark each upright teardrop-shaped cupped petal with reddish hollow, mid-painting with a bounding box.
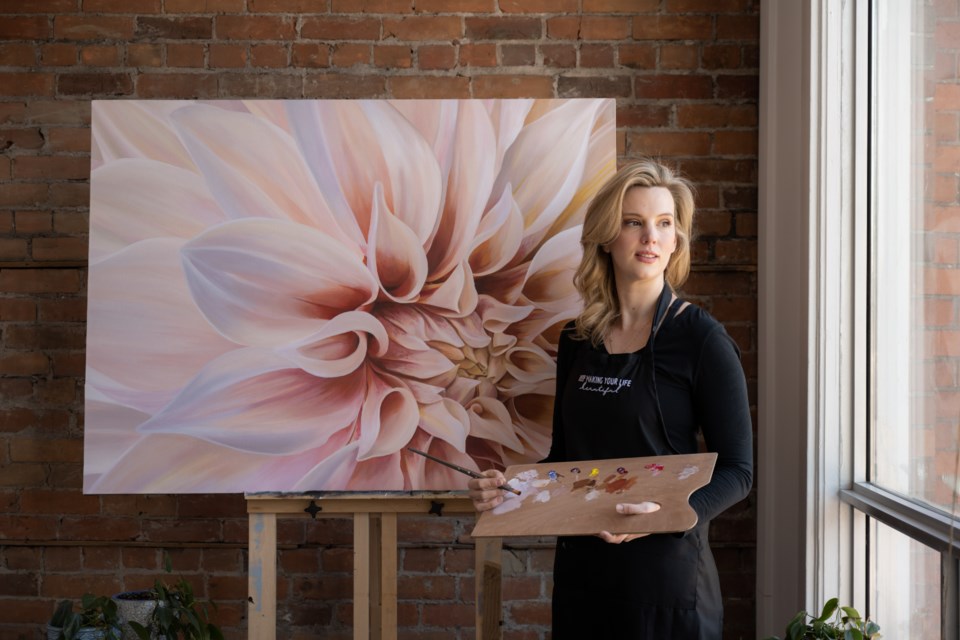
[367,183,427,302]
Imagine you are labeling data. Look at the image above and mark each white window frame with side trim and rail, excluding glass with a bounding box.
[757,0,960,640]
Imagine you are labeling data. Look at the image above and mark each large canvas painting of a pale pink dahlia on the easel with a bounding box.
[84,99,616,493]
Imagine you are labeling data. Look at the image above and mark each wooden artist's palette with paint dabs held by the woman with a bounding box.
[472,453,717,538]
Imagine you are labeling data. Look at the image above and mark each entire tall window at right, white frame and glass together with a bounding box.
[757,0,960,640]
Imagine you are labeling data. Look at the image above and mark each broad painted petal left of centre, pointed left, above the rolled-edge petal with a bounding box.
[182,218,377,346]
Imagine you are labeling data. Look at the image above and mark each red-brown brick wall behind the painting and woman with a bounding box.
[0,0,759,640]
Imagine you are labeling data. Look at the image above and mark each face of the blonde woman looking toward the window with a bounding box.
[605,187,677,286]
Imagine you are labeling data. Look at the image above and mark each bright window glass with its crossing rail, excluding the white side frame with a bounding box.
[845,0,960,640]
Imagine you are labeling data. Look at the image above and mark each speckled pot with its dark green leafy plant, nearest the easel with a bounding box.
[114,555,223,640]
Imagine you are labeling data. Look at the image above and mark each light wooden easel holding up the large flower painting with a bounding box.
[246,492,503,640]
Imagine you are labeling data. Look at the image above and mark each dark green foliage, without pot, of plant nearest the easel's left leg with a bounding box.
[121,555,223,640]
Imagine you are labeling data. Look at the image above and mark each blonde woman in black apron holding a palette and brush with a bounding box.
[469,160,753,640]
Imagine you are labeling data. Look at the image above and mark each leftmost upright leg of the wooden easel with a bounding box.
[247,513,277,640]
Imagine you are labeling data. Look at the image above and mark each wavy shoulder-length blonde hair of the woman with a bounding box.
[573,158,694,346]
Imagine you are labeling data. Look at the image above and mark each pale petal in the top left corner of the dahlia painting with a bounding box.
[90,100,196,171]
